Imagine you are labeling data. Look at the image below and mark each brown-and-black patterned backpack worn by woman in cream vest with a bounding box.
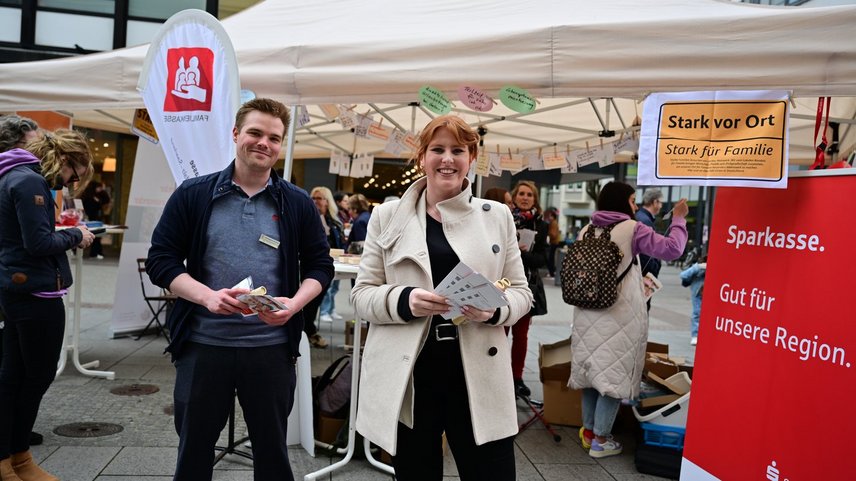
[561,223,637,309]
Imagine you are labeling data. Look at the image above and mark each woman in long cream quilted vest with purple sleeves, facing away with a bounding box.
[568,182,689,458]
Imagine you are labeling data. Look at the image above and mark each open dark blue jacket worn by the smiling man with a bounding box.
[146,161,334,359]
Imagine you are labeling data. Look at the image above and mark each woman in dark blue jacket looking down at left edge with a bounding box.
[0,130,95,481]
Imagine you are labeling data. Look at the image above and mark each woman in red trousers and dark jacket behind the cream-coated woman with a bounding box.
[511,180,548,397]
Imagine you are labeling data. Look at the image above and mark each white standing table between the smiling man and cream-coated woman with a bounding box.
[303,262,395,481]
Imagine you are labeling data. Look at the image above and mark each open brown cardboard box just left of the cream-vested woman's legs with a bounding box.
[538,339,583,426]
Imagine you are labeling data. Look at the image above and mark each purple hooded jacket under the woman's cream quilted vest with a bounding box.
[591,210,687,261]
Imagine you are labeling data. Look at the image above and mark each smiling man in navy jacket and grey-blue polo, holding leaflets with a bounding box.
[146,99,333,481]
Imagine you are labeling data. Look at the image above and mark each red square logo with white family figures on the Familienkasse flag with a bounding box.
[163,47,214,112]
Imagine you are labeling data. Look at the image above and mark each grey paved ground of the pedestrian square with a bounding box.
[28,253,695,481]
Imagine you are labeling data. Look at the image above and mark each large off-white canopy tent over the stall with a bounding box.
[0,0,856,159]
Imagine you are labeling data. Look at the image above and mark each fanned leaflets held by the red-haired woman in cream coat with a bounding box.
[434,262,508,319]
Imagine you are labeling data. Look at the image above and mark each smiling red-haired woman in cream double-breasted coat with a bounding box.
[351,115,532,481]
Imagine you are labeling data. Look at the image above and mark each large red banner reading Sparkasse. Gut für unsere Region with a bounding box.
[681,175,856,481]
